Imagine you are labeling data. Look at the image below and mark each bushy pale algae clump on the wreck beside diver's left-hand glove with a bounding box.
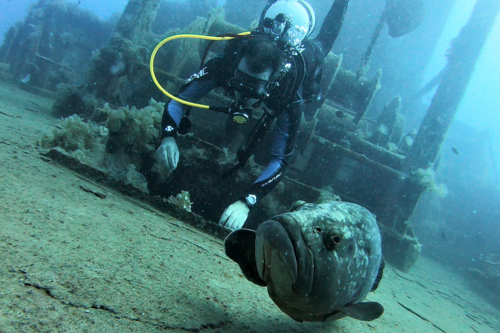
[40,99,164,193]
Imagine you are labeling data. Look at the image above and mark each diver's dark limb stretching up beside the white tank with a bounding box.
[314,0,349,57]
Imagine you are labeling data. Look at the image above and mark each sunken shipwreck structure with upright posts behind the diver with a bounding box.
[0,0,498,271]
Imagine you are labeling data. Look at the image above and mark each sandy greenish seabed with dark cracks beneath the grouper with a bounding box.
[0,82,500,333]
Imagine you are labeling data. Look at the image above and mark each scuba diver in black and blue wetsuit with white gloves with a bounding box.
[155,0,349,230]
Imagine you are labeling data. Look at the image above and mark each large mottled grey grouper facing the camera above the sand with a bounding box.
[224,201,384,322]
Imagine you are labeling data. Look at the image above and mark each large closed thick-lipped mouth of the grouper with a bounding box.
[255,214,314,294]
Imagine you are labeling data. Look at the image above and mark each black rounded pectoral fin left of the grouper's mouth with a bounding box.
[224,229,267,287]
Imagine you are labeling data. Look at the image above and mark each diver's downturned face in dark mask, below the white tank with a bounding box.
[233,57,272,105]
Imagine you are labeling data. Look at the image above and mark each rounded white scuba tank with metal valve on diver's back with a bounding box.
[259,0,316,47]
